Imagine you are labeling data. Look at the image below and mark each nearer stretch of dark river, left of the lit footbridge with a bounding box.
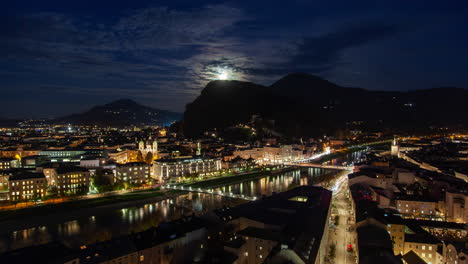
[0,193,241,252]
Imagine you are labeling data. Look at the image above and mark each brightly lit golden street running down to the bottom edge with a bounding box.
[327,173,357,264]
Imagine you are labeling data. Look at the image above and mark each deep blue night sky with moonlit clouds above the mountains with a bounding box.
[0,0,468,118]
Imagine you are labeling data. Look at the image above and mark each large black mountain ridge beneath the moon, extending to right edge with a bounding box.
[184,73,468,136]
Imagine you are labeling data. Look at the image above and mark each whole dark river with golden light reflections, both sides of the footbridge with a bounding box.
[0,152,361,251]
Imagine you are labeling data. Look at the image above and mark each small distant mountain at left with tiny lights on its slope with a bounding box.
[55,99,182,126]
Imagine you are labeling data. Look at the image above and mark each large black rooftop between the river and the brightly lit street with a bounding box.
[214,186,331,262]
